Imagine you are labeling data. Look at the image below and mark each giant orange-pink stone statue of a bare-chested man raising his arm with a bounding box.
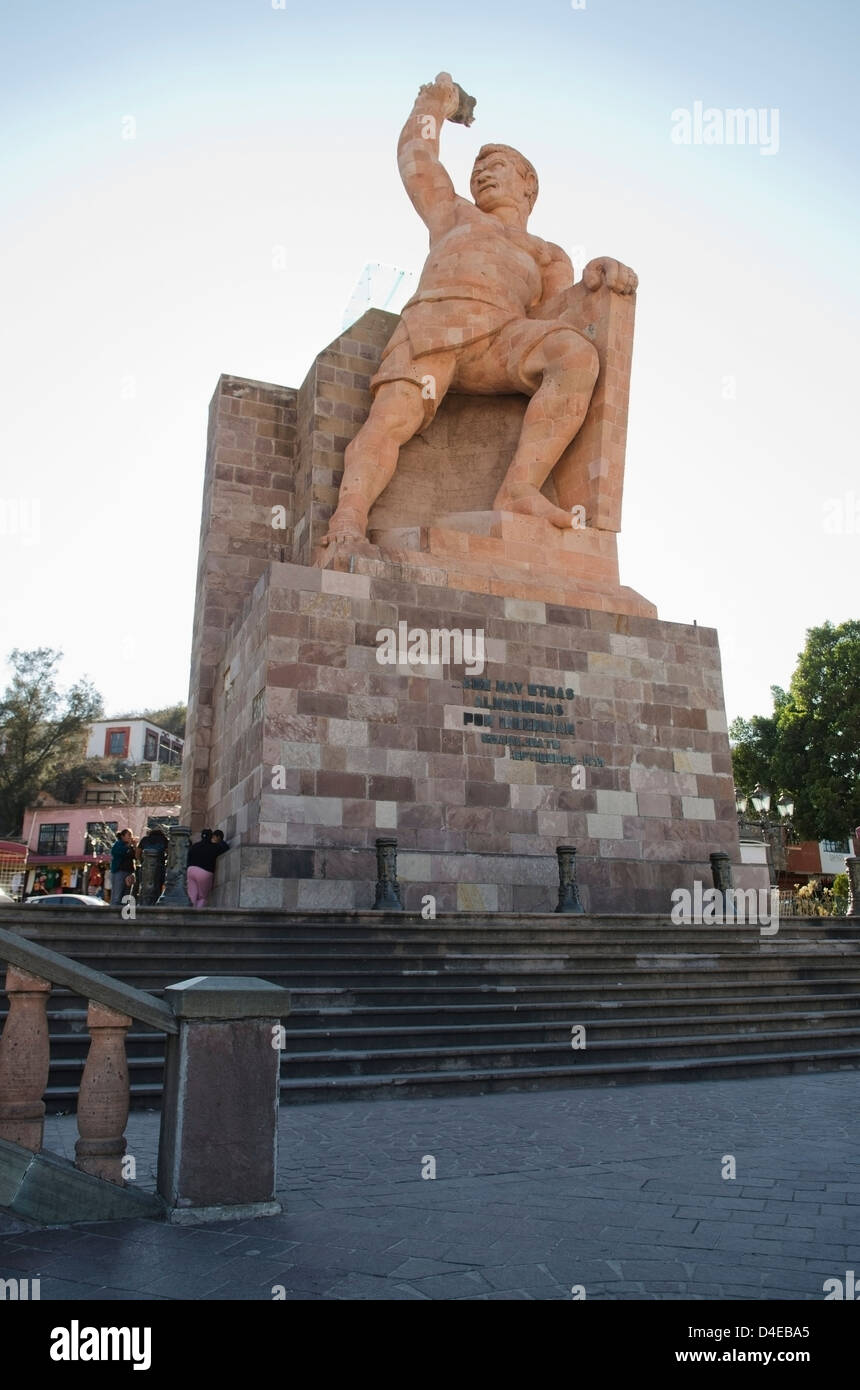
[322,72,636,545]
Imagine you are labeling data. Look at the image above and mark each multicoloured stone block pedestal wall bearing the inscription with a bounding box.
[204,563,759,912]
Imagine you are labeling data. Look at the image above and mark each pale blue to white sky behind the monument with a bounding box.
[0,0,860,717]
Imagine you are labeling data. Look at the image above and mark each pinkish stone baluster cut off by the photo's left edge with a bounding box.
[0,965,51,1154]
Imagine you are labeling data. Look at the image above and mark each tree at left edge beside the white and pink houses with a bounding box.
[0,646,103,835]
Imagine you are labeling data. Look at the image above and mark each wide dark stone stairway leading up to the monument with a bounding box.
[0,908,860,1111]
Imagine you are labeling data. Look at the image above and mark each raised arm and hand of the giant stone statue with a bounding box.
[397,72,468,236]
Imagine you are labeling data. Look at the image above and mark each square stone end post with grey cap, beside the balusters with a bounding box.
[158,976,289,1225]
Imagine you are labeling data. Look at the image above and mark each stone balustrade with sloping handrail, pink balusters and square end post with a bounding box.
[0,930,289,1223]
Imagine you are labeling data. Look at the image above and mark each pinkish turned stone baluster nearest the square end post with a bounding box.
[75,1002,132,1187]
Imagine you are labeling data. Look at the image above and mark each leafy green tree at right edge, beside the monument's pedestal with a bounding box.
[729,620,860,840]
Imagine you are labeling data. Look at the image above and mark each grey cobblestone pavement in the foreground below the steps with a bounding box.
[0,1072,860,1300]
